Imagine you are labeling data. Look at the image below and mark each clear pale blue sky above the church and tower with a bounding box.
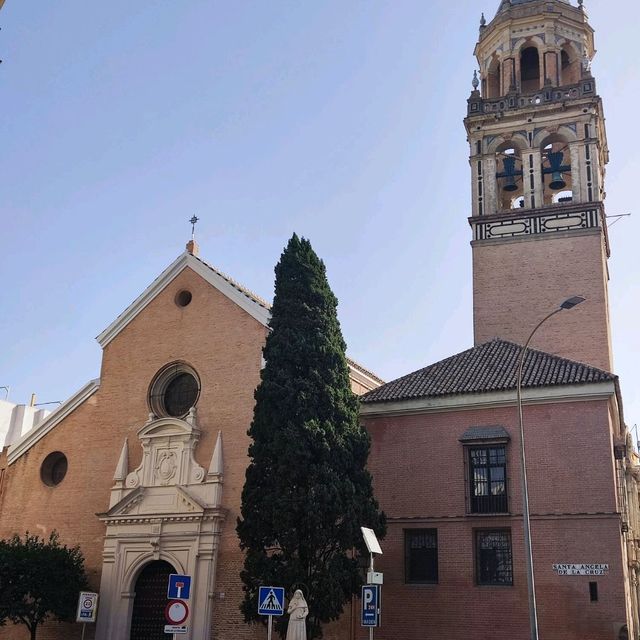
[0,0,640,425]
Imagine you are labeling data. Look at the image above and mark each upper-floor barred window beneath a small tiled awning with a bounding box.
[469,446,509,513]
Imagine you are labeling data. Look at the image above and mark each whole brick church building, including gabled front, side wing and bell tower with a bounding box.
[0,0,640,640]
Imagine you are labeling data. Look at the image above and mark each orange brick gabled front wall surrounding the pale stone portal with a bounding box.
[0,269,368,640]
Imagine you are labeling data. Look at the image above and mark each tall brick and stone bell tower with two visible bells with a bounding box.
[465,0,612,371]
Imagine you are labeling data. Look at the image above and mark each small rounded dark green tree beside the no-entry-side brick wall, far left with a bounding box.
[0,531,87,639]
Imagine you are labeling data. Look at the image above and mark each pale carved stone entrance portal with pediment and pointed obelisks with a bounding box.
[96,409,225,640]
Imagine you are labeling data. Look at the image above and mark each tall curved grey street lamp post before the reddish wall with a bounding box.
[516,296,585,640]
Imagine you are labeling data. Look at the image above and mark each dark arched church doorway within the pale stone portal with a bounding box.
[129,560,176,640]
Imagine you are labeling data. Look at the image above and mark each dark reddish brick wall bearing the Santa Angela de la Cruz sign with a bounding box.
[357,400,626,640]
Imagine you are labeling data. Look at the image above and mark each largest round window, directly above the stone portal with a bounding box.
[149,362,200,418]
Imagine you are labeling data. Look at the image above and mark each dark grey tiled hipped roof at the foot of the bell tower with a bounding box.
[361,339,616,402]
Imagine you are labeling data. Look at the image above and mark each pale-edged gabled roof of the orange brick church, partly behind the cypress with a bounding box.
[96,251,384,387]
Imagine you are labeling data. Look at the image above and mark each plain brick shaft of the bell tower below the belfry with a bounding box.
[473,231,612,371]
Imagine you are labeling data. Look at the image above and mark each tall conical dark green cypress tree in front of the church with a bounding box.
[237,234,385,640]
